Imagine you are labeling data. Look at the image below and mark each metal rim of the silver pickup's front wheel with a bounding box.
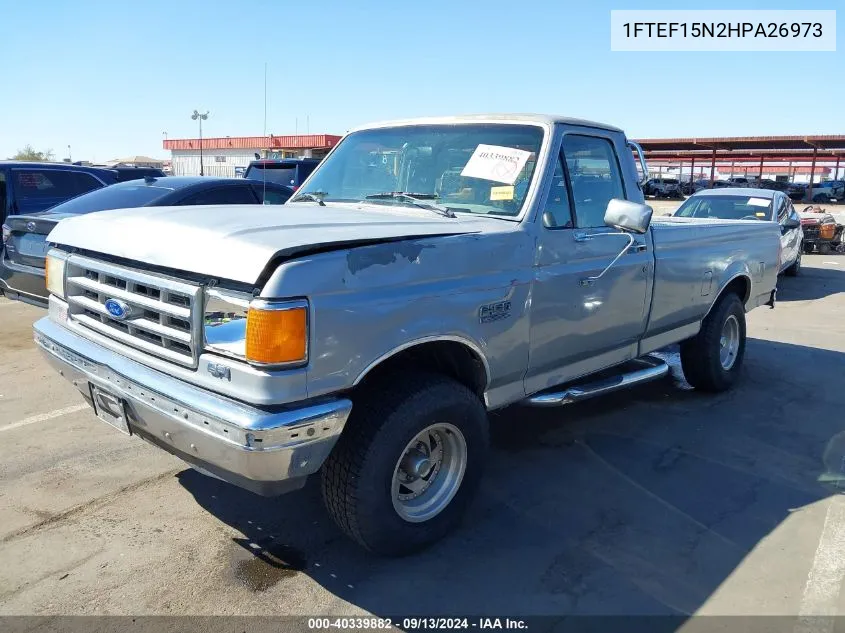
[390,423,467,523]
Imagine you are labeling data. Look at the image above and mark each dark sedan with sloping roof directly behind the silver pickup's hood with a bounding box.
[0,176,293,307]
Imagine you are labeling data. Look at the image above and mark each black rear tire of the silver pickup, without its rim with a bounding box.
[681,292,745,392]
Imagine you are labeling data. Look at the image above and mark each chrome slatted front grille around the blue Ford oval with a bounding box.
[65,255,202,367]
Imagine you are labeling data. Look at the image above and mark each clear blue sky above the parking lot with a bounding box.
[0,0,845,161]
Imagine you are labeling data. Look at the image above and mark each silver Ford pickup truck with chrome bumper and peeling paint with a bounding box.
[35,115,780,555]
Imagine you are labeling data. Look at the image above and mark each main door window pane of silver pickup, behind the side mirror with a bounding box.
[563,134,625,228]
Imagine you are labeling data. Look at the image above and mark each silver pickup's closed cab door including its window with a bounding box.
[525,128,654,393]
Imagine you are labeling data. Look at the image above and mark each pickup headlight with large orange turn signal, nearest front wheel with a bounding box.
[203,288,308,367]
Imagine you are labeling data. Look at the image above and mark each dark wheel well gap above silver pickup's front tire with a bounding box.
[360,341,487,397]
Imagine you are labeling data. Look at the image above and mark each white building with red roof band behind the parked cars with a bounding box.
[164,134,341,177]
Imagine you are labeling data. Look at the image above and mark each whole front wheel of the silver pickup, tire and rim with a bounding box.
[322,373,489,556]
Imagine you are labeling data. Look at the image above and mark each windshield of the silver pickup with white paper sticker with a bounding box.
[291,123,543,217]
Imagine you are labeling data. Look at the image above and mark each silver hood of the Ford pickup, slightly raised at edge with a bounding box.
[47,202,502,284]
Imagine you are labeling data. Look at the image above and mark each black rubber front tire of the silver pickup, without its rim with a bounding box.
[321,372,490,556]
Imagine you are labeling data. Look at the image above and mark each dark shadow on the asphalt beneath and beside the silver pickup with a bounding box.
[179,339,845,617]
